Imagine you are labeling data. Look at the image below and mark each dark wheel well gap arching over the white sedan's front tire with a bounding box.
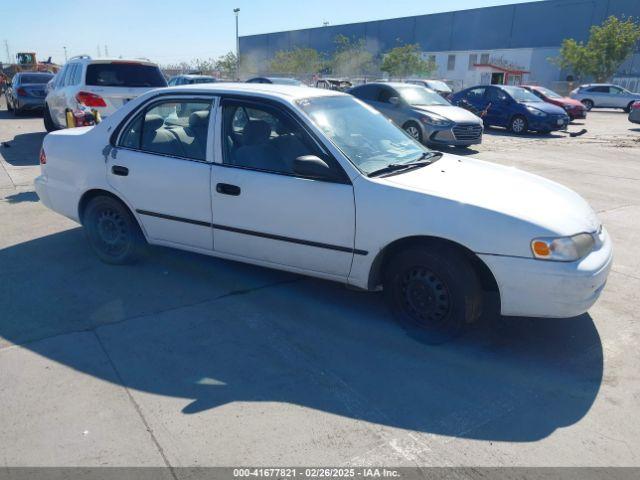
[368,236,499,293]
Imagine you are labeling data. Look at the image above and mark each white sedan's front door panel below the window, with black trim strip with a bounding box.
[211,165,361,277]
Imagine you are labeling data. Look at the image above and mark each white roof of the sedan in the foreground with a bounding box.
[161,82,346,101]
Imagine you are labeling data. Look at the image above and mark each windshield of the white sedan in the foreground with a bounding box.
[297,96,429,174]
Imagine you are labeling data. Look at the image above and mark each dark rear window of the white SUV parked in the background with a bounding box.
[86,63,167,87]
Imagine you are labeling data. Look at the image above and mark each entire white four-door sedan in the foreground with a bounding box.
[35,83,612,339]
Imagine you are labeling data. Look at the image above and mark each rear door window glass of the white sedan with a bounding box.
[119,100,211,161]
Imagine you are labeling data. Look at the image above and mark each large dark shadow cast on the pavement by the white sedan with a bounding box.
[0,228,603,442]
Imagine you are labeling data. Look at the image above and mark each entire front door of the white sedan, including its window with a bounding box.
[211,99,355,278]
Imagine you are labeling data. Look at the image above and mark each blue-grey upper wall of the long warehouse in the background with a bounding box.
[240,0,640,70]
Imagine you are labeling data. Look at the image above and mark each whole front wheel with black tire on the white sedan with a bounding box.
[384,245,482,344]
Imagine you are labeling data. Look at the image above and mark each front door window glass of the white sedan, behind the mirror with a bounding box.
[222,101,324,175]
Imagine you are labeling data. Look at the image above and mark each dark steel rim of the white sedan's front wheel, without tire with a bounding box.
[400,267,451,328]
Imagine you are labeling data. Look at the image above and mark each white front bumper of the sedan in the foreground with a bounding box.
[480,229,613,318]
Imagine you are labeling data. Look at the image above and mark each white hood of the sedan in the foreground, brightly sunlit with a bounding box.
[384,154,600,236]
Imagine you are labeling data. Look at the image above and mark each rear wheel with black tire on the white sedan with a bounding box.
[82,195,145,265]
